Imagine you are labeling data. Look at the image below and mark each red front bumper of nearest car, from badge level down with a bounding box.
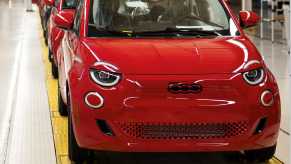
[71,73,280,152]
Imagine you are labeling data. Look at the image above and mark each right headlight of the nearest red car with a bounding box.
[243,68,265,85]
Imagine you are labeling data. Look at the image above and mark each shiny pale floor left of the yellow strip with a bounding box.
[0,0,56,164]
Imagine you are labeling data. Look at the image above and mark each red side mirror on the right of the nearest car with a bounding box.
[239,11,261,28]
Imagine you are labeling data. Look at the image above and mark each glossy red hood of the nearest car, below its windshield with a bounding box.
[83,38,260,75]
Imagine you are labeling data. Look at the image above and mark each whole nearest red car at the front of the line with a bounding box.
[54,0,280,161]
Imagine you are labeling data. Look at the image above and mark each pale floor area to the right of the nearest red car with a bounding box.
[252,38,291,163]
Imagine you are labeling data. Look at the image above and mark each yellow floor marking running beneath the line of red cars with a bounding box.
[41,17,283,164]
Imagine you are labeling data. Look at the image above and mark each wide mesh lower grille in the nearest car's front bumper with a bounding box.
[117,121,248,140]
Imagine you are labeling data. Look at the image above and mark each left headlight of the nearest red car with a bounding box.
[90,69,121,87]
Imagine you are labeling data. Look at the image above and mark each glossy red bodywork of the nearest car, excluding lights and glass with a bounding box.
[58,0,280,152]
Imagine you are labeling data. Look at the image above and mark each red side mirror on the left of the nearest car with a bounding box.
[53,9,75,29]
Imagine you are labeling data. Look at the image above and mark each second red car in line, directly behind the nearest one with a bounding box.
[47,0,76,78]
